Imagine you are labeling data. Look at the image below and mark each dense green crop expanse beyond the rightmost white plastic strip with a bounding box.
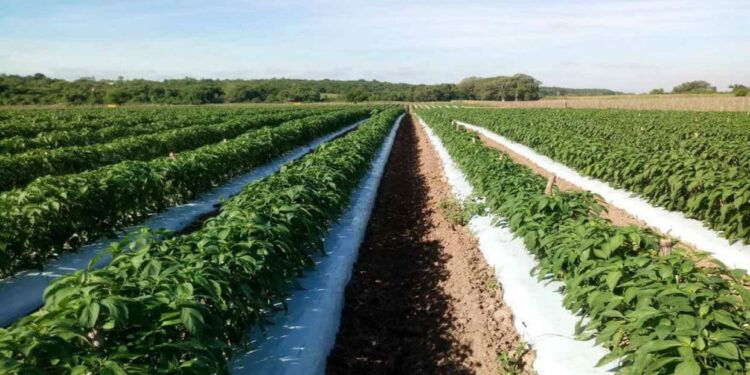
[438,109,750,243]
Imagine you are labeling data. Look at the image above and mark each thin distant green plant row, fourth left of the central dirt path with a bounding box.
[0,106,314,154]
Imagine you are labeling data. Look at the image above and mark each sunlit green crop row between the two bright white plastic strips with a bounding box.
[420,111,750,375]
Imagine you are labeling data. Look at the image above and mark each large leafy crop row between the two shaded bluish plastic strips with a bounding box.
[0,109,400,374]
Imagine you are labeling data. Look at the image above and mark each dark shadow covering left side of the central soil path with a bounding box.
[326,116,473,375]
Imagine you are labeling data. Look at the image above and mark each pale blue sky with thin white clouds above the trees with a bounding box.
[0,0,750,92]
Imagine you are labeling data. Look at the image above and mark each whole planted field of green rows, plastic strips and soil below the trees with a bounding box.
[0,103,750,374]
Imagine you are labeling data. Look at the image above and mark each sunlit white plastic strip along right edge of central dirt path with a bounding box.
[419,119,616,375]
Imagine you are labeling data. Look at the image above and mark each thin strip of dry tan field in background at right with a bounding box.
[459,94,750,112]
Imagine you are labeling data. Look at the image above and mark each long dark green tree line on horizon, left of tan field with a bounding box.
[0,73,543,105]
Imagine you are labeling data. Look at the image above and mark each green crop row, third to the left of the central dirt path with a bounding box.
[0,110,330,190]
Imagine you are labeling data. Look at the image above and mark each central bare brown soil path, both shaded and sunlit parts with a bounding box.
[327,117,533,374]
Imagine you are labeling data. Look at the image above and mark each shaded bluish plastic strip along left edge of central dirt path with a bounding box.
[228,115,403,375]
